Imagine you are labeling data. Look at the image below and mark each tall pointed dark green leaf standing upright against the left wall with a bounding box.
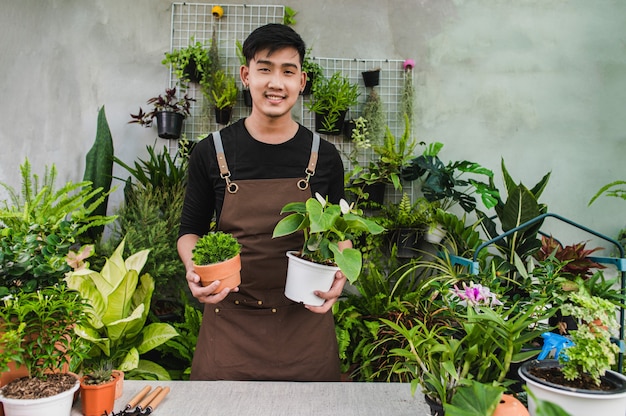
[83,106,113,241]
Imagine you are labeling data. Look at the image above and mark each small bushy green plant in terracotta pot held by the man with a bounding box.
[191,231,241,293]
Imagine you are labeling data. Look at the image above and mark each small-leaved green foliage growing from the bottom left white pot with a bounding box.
[0,285,87,378]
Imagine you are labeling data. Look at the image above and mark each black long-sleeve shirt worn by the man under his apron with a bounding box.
[179,119,344,236]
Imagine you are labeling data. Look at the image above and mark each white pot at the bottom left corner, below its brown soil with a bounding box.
[0,380,80,416]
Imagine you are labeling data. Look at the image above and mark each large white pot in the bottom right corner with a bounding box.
[518,360,626,416]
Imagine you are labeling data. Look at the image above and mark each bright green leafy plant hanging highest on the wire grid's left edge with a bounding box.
[161,36,211,85]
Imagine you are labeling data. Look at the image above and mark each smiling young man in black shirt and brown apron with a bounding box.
[178,24,350,381]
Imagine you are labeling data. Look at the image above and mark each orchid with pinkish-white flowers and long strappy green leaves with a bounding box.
[383,272,553,414]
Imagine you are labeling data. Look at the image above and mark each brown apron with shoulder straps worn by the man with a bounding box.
[191,133,339,381]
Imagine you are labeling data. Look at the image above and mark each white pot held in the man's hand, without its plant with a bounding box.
[285,251,339,306]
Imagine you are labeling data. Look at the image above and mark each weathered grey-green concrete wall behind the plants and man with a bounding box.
[0,0,626,250]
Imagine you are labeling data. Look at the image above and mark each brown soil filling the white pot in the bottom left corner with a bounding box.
[2,373,77,399]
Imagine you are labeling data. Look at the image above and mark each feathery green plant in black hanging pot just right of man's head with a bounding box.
[305,72,359,135]
